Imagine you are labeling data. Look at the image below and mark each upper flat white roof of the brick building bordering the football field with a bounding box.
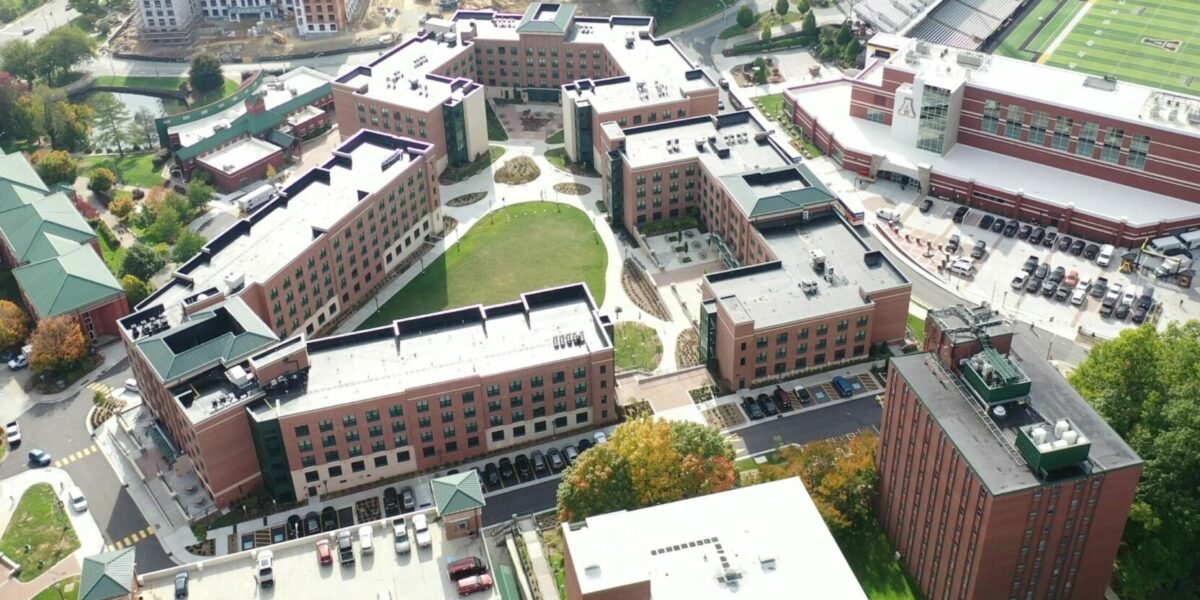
[883,37,1200,137]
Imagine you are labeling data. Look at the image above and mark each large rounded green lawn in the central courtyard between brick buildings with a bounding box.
[359,202,608,329]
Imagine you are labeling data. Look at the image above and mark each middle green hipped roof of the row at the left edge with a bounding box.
[0,193,96,263]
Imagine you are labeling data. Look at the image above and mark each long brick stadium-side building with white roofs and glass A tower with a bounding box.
[785,35,1200,246]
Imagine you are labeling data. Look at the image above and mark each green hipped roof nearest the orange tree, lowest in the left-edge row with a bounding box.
[12,242,125,318]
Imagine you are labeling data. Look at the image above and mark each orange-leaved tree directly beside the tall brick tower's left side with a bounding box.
[758,431,880,529]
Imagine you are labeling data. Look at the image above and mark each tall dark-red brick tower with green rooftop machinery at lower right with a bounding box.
[877,306,1142,599]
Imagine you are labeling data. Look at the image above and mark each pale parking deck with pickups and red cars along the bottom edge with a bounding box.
[139,512,498,600]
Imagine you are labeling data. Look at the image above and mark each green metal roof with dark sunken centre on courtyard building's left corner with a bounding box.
[137,298,278,382]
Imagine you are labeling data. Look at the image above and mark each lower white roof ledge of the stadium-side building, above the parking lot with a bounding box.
[787,80,1200,226]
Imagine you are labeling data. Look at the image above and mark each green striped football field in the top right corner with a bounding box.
[1040,0,1200,95]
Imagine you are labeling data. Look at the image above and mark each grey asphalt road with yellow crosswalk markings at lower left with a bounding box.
[0,361,175,571]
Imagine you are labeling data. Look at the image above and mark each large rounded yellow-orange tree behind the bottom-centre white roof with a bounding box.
[558,419,737,522]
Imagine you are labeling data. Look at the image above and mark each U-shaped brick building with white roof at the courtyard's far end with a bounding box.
[334,2,718,172]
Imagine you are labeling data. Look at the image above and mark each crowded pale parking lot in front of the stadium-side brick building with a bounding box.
[869,199,1198,338]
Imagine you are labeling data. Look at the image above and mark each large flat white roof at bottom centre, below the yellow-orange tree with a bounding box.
[563,478,866,600]
